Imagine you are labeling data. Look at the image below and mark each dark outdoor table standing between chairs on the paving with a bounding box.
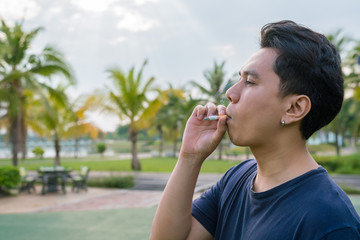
[38,166,71,195]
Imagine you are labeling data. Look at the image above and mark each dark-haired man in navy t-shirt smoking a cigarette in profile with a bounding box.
[150,21,360,240]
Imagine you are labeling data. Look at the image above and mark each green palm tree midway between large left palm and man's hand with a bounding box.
[106,61,162,170]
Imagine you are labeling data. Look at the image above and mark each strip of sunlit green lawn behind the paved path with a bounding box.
[0,153,360,174]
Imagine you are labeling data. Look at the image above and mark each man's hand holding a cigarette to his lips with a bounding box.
[180,103,226,164]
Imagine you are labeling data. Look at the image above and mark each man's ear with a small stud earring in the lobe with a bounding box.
[281,95,311,125]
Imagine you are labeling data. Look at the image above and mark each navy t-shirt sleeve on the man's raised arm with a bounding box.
[192,180,221,236]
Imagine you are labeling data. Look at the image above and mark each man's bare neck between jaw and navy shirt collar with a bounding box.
[251,135,318,192]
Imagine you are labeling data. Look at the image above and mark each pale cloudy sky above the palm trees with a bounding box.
[0,0,360,131]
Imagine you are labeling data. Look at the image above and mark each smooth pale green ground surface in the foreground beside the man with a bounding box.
[0,195,360,240]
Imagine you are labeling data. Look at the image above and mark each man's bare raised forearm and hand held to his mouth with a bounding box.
[150,104,226,240]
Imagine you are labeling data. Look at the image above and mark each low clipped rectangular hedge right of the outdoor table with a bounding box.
[87,176,135,188]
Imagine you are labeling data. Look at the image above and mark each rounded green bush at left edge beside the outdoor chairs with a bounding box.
[0,167,21,193]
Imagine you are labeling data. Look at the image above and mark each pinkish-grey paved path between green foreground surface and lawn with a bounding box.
[0,172,360,214]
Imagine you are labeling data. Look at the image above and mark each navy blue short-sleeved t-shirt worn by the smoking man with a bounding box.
[192,160,360,240]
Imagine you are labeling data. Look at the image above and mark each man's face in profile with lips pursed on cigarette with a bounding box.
[226,48,284,147]
